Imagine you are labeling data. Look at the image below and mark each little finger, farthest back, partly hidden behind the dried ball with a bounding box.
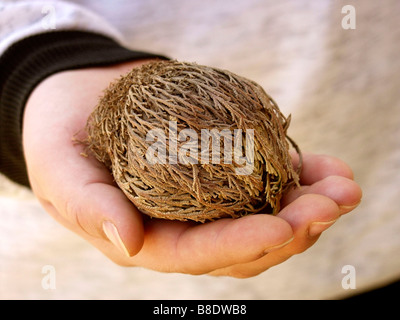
[291,152,353,185]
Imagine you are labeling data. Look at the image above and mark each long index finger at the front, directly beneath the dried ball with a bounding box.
[134,214,293,274]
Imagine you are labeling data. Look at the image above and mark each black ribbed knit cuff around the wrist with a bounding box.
[0,31,168,187]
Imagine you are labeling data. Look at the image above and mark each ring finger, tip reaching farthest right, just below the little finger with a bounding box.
[281,176,362,214]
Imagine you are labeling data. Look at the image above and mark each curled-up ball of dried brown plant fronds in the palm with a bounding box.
[86,60,301,222]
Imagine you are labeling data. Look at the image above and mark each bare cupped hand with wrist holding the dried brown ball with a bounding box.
[23,61,362,278]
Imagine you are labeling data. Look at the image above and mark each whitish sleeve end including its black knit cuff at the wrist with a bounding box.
[0,2,168,187]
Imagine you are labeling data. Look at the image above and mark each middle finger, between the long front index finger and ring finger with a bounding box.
[210,195,339,278]
